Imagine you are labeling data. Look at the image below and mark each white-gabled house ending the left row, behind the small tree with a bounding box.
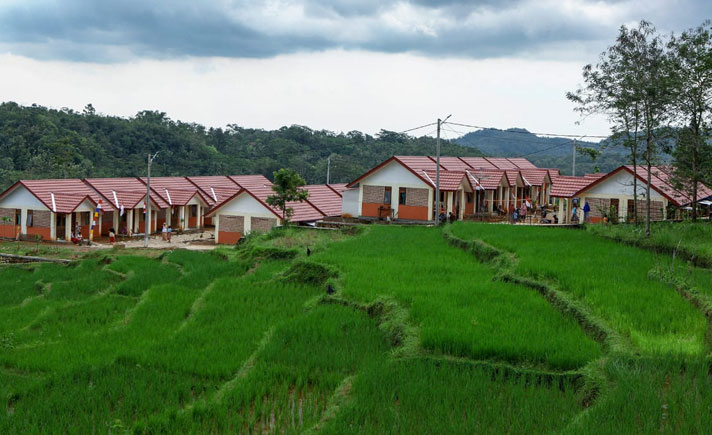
[206,184,324,245]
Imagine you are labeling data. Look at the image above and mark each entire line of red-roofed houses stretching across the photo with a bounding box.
[0,156,712,244]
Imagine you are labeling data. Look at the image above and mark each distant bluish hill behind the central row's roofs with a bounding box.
[456,128,628,175]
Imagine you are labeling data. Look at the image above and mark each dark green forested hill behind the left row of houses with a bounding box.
[0,102,482,189]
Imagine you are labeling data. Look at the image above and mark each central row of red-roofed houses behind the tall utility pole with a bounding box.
[343,156,559,221]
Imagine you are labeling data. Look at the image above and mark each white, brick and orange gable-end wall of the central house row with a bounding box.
[358,161,434,220]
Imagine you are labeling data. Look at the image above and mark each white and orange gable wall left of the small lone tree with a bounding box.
[213,192,281,244]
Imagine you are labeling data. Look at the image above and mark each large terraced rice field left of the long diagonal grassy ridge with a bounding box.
[0,228,599,433]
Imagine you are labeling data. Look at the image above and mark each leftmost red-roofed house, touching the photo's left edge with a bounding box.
[0,179,114,240]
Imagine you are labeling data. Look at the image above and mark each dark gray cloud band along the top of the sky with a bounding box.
[0,0,712,62]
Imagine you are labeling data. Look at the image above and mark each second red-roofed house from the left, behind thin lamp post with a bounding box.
[84,177,171,236]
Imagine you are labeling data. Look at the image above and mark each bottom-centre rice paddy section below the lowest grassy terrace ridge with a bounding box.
[321,359,582,434]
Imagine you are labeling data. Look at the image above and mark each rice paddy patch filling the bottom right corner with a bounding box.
[565,358,712,434]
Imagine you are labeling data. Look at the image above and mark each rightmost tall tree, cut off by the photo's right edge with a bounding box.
[668,20,712,220]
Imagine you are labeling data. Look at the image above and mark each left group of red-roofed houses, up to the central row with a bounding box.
[0,175,345,243]
